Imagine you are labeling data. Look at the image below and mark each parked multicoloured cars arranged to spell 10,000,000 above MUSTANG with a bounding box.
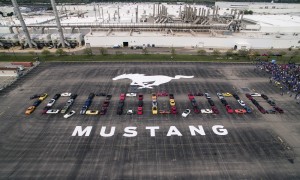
[25,91,284,118]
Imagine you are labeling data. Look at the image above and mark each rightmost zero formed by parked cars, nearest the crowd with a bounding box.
[245,93,284,114]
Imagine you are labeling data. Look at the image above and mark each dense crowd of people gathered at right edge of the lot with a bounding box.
[256,60,300,103]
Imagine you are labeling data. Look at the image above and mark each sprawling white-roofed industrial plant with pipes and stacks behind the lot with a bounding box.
[0,0,300,49]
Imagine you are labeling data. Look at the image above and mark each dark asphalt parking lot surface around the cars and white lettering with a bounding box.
[0,62,300,180]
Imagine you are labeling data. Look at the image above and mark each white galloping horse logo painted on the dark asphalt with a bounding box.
[113,74,194,89]
